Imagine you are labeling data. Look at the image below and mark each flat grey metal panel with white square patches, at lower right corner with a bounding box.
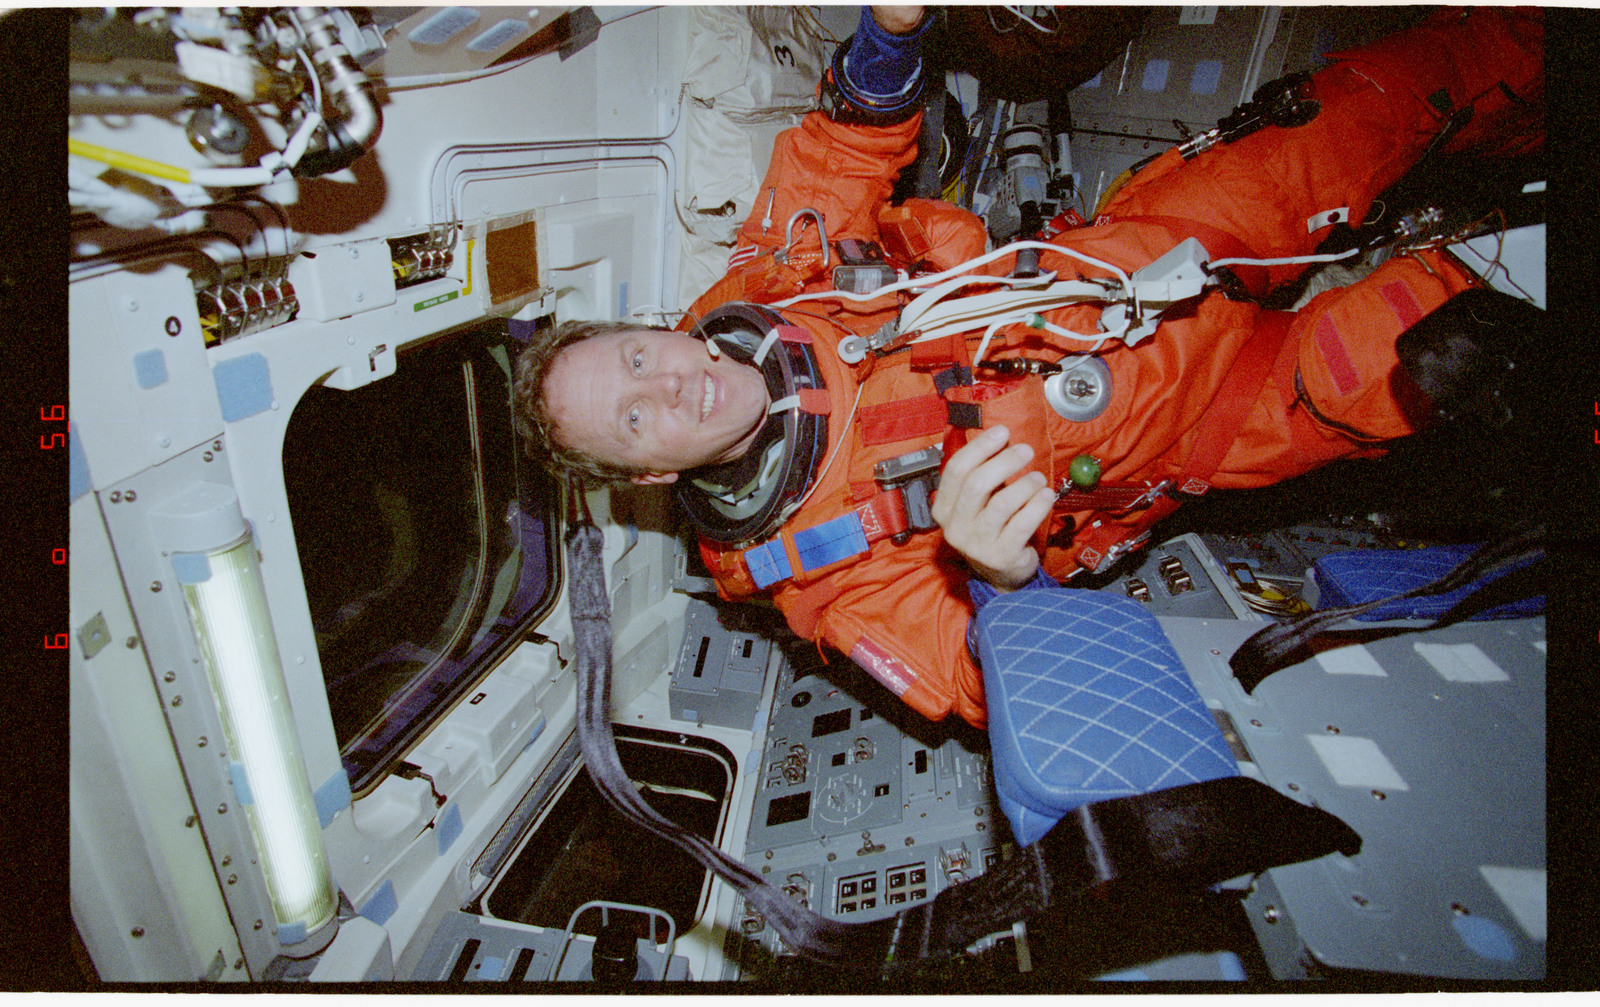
[1162,618,1546,978]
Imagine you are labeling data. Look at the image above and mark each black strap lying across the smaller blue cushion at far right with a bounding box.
[1227,525,1546,693]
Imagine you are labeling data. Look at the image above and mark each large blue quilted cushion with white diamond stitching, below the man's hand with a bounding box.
[976,589,1238,844]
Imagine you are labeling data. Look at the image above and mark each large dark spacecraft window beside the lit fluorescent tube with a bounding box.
[283,322,560,794]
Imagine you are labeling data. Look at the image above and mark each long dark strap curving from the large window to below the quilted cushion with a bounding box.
[566,522,1362,978]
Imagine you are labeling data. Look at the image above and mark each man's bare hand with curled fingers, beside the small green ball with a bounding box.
[933,426,1056,591]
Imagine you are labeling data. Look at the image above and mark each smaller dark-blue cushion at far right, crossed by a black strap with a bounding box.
[1312,544,1544,621]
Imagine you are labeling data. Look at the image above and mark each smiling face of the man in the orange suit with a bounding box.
[544,328,771,483]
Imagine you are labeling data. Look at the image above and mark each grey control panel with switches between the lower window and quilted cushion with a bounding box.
[728,645,1014,978]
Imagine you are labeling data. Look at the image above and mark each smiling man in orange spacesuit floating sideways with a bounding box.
[515,8,1542,727]
